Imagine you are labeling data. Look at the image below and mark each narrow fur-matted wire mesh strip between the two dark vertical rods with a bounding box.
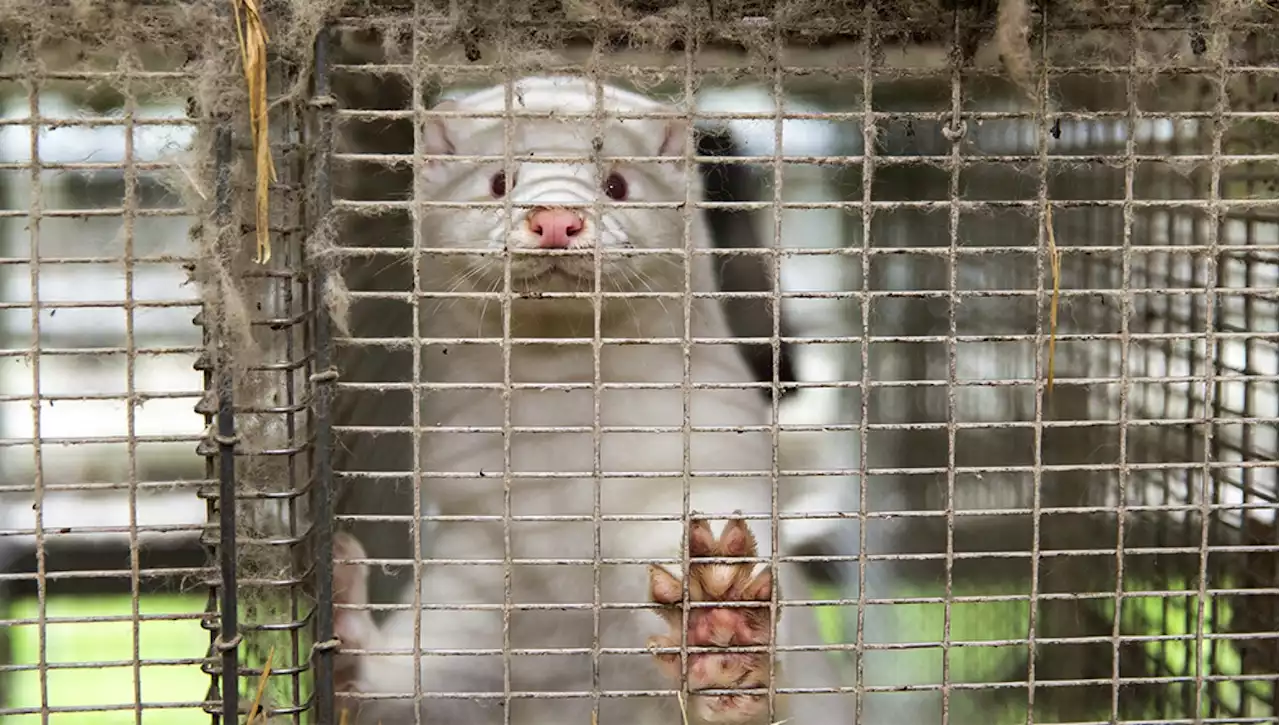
[197,36,322,724]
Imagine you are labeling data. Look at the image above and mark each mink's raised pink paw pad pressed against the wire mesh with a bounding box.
[649,519,773,725]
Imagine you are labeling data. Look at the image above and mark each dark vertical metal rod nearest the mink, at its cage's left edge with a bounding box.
[307,28,338,725]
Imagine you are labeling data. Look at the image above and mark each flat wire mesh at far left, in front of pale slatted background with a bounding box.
[0,19,209,724]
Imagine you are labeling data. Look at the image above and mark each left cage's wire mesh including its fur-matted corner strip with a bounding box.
[0,3,325,722]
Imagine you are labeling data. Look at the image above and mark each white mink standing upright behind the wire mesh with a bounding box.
[335,77,854,725]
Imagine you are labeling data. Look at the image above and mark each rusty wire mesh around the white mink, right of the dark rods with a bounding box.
[320,5,1280,722]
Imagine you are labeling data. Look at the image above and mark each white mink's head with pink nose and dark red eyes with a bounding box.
[419,77,701,304]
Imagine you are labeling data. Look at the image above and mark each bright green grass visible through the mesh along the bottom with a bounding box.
[0,589,1267,725]
